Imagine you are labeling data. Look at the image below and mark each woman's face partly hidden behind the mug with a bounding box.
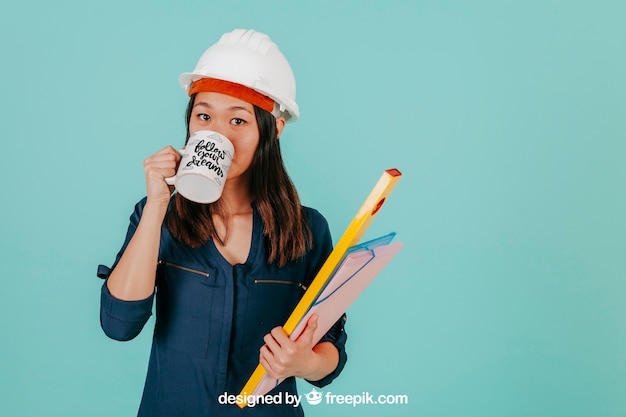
[189,93,259,184]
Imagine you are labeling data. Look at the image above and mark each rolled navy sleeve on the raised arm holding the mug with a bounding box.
[97,199,154,341]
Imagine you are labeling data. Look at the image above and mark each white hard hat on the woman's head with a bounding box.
[179,29,300,120]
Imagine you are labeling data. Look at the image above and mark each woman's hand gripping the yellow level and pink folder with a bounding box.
[259,314,339,381]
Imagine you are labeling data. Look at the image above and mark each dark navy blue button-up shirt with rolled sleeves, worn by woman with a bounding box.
[98,198,346,417]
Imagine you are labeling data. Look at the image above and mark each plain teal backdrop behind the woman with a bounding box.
[0,0,626,417]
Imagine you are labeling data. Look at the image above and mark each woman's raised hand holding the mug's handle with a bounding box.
[143,146,181,204]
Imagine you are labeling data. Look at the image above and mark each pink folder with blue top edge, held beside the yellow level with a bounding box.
[251,233,402,395]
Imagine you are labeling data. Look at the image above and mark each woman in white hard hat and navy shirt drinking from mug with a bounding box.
[98,30,346,417]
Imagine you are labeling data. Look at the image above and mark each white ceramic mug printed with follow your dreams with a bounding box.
[165,130,235,204]
